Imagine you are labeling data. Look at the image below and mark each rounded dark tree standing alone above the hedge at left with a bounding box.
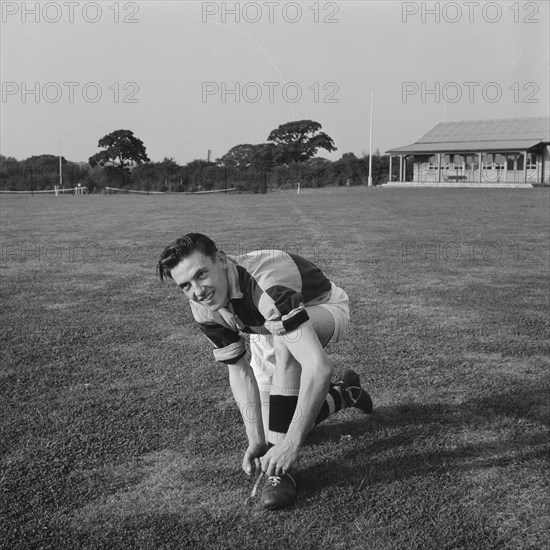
[88,130,149,185]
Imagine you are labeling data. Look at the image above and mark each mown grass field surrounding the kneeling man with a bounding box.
[0,188,550,550]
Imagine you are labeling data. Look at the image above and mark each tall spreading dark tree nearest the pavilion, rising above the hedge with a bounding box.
[267,120,336,164]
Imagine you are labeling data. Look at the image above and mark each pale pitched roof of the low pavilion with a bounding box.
[387,117,550,154]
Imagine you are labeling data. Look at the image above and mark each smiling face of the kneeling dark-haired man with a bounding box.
[170,250,229,311]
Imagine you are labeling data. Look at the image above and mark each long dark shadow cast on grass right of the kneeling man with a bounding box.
[299,388,549,499]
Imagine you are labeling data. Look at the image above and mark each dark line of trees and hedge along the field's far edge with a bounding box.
[0,120,396,193]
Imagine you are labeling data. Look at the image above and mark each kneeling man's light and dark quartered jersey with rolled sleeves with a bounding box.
[190,250,331,364]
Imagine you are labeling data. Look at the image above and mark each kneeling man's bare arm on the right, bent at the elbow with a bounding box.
[261,320,332,475]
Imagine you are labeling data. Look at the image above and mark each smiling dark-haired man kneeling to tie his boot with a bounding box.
[157,233,372,509]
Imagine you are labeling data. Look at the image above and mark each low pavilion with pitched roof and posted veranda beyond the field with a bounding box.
[386,117,550,187]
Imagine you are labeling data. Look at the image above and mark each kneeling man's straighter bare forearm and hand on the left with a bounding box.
[228,357,267,474]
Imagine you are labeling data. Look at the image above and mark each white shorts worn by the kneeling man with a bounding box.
[250,282,350,392]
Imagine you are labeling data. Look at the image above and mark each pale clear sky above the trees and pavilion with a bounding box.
[0,0,550,165]
